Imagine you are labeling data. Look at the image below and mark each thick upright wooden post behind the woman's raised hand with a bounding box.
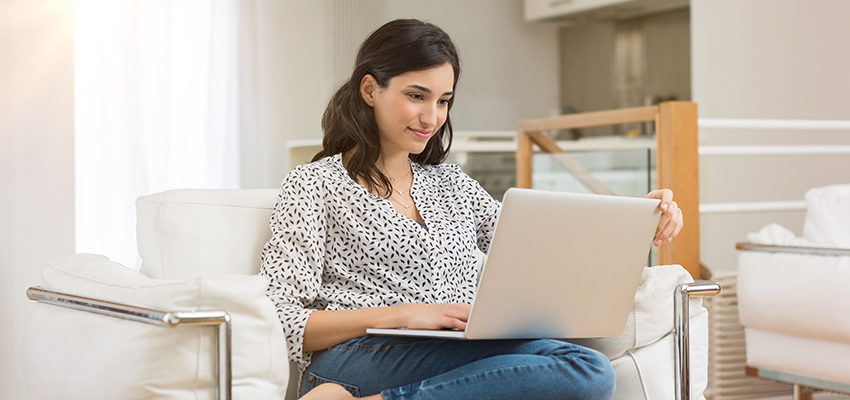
[655,101,701,279]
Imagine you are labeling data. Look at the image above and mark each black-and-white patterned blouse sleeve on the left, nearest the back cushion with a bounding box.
[260,169,325,370]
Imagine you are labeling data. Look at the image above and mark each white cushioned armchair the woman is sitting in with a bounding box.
[23,190,710,400]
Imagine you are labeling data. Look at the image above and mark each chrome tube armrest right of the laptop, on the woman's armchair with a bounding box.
[673,280,720,400]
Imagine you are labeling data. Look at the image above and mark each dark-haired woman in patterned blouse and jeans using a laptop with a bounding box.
[261,20,682,399]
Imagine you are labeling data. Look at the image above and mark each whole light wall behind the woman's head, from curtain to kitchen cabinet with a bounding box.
[240,0,560,187]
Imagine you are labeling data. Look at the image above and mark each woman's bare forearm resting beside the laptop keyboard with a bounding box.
[304,307,404,352]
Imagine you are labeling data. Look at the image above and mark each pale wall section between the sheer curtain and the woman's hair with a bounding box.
[239,0,337,188]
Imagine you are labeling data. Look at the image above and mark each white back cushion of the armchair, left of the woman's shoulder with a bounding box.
[136,189,278,280]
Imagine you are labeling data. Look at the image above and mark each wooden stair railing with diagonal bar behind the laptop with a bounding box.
[516,101,702,279]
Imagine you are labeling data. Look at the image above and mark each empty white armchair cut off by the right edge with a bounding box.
[737,185,850,399]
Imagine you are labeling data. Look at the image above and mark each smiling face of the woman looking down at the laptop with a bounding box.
[364,63,454,155]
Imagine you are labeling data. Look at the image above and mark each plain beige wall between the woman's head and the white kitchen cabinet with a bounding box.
[385,0,560,130]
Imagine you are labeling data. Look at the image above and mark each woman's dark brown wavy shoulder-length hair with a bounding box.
[313,19,460,197]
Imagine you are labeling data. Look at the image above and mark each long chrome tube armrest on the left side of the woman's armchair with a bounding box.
[27,287,232,400]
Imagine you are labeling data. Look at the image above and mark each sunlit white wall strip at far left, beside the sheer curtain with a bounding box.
[0,0,74,399]
